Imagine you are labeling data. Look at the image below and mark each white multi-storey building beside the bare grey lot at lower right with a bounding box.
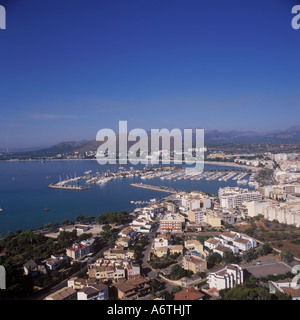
[207,264,244,290]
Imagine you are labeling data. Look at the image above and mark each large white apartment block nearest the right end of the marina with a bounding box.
[218,187,262,209]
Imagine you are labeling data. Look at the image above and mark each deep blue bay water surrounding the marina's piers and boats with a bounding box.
[0,160,248,234]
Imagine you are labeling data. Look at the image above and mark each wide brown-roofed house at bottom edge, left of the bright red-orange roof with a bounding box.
[114,276,150,300]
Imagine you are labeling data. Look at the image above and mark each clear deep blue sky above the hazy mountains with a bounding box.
[0,0,300,147]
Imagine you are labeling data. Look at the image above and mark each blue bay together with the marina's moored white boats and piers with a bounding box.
[0,160,255,233]
